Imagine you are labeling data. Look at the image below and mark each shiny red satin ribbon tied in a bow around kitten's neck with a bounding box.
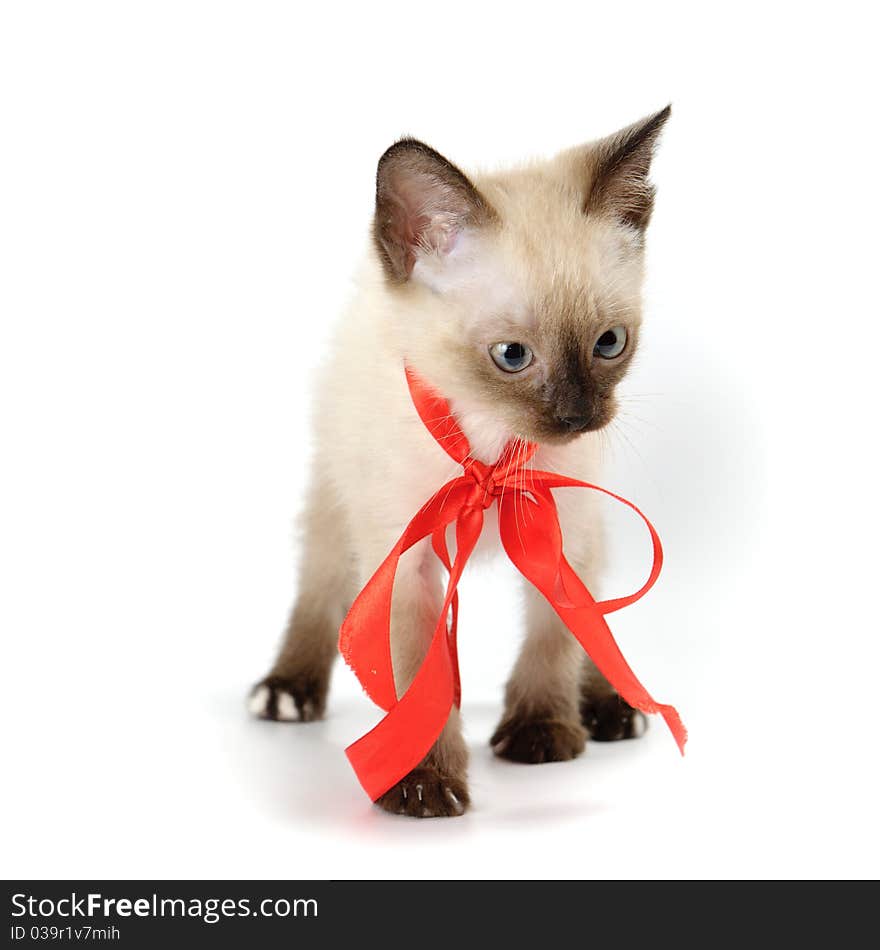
[339,369,687,801]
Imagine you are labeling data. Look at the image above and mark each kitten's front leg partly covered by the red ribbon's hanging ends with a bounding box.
[376,543,470,818]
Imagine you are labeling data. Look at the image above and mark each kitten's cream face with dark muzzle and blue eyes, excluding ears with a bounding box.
[411,201,642,443]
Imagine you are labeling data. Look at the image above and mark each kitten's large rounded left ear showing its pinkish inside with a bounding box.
[373,139,496,283]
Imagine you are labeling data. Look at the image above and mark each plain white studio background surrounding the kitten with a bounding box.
[0,2,880,878]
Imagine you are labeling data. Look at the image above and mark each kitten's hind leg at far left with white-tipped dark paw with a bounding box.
[250,486,354,722]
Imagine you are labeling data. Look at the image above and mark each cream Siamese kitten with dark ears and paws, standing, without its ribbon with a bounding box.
[251,107,669,817]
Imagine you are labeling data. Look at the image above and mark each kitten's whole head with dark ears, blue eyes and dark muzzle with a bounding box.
[374,107,669,443]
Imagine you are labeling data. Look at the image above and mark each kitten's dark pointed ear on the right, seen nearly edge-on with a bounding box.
[584,106,672,231]
